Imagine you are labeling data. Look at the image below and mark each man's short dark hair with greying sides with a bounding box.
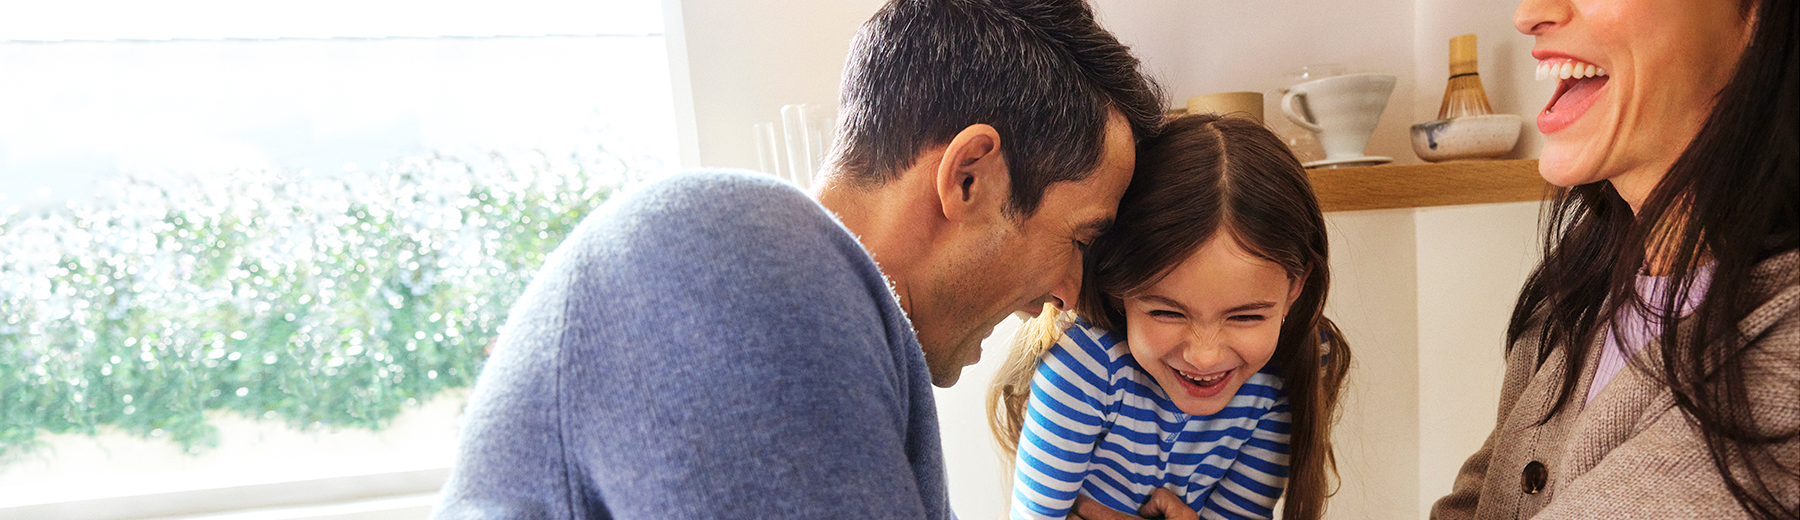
[832,0,1163,218]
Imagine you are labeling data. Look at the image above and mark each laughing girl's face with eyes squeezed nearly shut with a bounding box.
[1123,232,1303,416]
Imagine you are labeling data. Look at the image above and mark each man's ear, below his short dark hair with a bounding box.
[938,124,1012,221]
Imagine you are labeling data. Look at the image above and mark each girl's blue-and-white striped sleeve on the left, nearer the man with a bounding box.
[1012,326,1118,520]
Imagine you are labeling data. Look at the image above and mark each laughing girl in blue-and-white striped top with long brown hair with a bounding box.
[988,115,1350,518]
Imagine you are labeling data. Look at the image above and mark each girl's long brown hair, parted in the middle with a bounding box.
[988,113,1350,520]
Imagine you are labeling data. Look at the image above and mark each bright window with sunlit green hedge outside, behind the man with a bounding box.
[0,0,675,518]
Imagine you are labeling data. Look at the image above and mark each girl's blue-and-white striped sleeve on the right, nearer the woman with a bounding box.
[1195,385,1292,520]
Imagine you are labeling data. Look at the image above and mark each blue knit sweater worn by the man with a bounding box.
[434,171,950,520]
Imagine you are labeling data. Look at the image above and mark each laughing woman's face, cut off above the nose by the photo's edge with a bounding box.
[1514,0,1750,205]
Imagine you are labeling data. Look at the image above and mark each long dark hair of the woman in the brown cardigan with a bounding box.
[1507,0,1800,518]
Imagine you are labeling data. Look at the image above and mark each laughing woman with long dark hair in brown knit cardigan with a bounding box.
[1431,0,1800,518]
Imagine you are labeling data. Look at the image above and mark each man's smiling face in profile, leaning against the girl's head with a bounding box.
[914,113,1138,387]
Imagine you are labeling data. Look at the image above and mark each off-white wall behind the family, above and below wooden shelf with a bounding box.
[664,0,1550,518]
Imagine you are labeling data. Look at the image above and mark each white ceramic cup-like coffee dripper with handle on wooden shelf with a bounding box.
[1282,74,1393,160]
